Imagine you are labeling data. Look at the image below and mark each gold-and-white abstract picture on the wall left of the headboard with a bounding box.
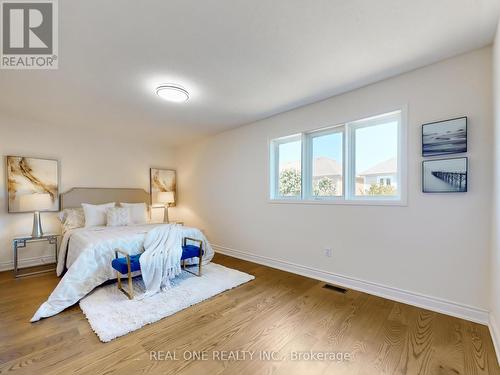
[6,156,59,213]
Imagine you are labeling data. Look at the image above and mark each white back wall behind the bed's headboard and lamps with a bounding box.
[0,114,175,270]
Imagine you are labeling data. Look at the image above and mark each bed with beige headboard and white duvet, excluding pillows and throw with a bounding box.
[31,188,214,322]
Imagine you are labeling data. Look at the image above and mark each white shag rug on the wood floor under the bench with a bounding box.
[80,263,255,342]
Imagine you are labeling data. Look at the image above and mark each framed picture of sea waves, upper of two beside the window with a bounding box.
[422,117,467,156]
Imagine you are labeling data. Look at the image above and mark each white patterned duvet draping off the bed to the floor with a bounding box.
[31,224,214,322]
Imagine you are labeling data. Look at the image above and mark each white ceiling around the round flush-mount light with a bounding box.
[0,0,500,144]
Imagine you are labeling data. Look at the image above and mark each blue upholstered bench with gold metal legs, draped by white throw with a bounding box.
[111,237,205,299]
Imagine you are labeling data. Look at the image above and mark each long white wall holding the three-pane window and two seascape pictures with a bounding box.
[179,47,493,316]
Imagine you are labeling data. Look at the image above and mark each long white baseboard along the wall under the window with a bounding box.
[212,244,490,325]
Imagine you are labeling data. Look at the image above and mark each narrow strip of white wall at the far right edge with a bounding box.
[490,23,500,361]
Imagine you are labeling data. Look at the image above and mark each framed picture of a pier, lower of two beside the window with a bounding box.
[422,157,468,193]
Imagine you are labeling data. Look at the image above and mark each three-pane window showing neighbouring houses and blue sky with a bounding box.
[271,111,406,203]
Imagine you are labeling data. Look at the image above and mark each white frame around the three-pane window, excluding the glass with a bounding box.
[268,106,408,206]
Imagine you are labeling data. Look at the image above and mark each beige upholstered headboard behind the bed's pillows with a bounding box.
[61,188,150,210]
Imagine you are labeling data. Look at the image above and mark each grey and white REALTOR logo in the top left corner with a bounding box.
[0,0,58,69]
